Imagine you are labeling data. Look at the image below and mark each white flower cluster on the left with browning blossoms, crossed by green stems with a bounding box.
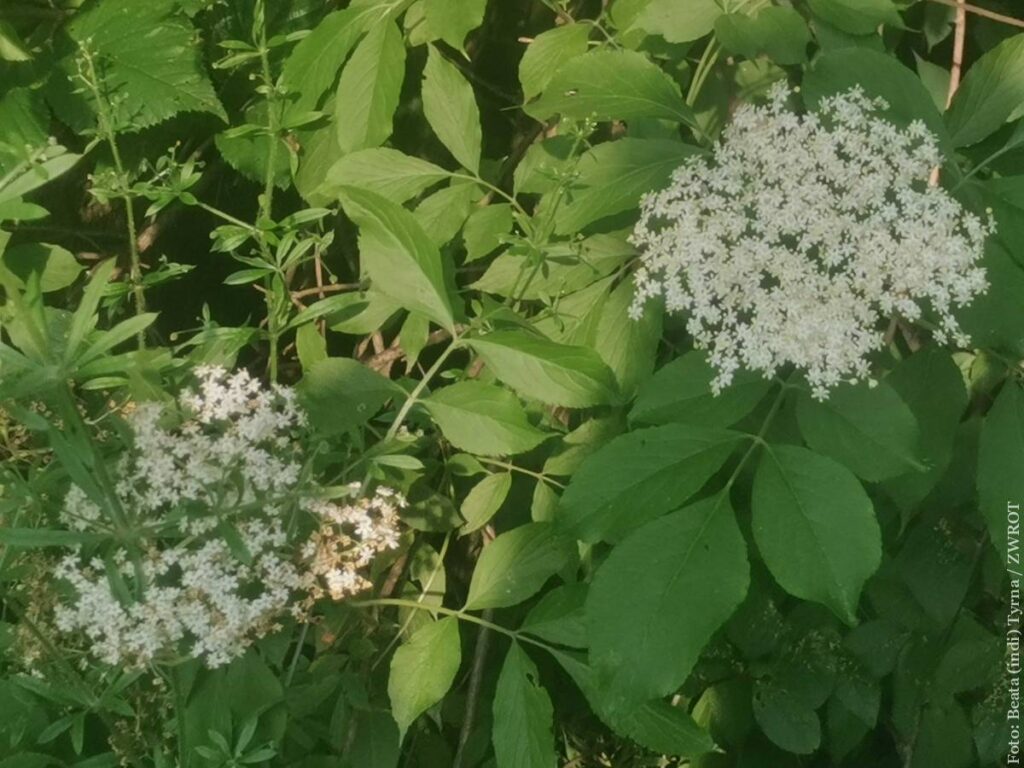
[55,368,406,667]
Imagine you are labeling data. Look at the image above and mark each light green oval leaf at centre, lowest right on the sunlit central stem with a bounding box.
[423,381,548,456]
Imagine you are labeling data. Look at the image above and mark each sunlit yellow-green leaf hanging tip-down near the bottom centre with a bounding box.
[387,616,462,739]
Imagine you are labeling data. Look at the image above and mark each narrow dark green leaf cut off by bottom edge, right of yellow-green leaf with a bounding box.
[492,642,558,768]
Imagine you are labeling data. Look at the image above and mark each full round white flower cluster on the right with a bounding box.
[632,85,992,398]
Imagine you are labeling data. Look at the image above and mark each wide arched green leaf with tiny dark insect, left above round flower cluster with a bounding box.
[523,49,694,125]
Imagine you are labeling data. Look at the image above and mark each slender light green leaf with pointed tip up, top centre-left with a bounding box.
[423,45,481,173]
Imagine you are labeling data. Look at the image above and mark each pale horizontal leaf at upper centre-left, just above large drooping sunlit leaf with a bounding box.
[318,146,452,203]
